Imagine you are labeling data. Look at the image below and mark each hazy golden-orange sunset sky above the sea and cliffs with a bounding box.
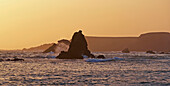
[0,0,170,49]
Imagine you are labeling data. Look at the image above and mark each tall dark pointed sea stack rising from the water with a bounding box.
[57,30,94,59]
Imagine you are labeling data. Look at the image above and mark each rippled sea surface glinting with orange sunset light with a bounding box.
[0,51,170,86]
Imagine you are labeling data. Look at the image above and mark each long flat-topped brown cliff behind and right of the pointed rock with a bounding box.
[86,32,170,52]
